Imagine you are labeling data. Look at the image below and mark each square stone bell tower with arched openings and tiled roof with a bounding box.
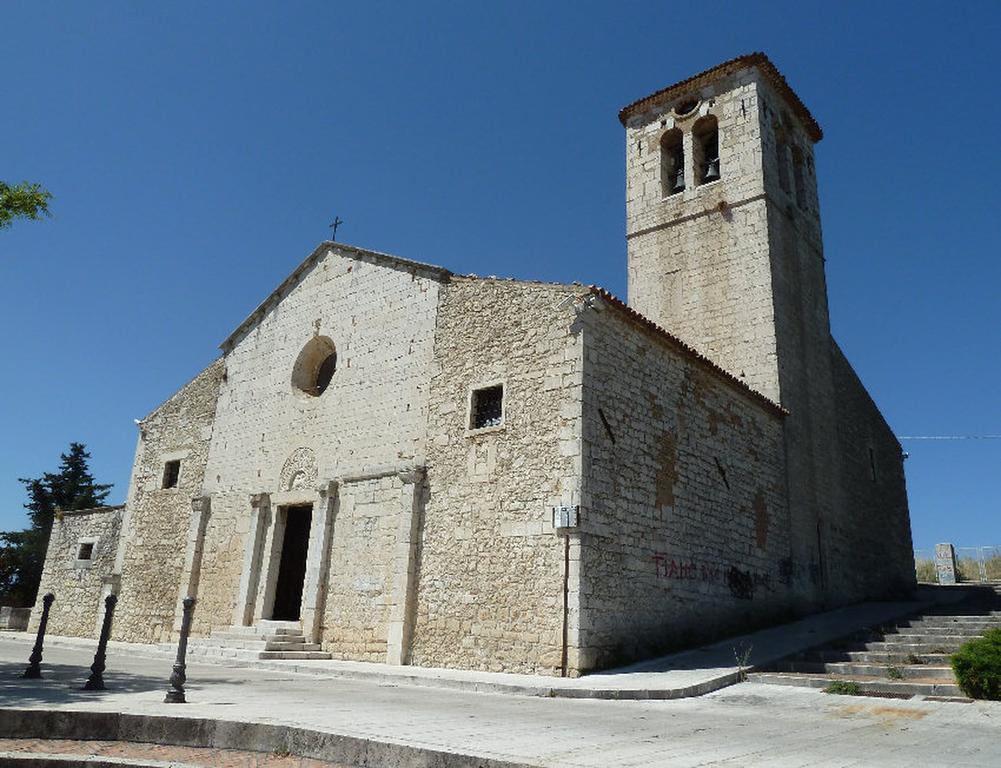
[620,53,841,603]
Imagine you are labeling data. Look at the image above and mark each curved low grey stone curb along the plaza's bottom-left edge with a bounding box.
[0,709,530,768]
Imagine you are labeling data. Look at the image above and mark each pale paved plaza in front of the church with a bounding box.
[0,636,1001,768]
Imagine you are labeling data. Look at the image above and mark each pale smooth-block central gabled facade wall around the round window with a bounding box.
[194,243,442,636]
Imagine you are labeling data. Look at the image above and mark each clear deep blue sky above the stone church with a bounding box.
[0,1,1001,547]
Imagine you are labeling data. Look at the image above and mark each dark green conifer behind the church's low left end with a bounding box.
[0,443,111,606]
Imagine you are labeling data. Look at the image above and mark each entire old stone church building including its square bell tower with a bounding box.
[34,54,914,675]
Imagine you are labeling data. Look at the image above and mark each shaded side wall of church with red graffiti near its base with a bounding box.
[580,305,796,669]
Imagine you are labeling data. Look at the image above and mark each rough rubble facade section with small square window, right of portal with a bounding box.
[410,278,582,674]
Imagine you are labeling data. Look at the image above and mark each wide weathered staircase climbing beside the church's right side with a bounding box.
[748,586,1001,699]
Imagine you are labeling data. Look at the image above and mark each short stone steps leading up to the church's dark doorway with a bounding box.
[187,621,330,659]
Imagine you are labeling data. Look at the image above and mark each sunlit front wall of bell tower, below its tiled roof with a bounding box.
[626,69,780,402]
